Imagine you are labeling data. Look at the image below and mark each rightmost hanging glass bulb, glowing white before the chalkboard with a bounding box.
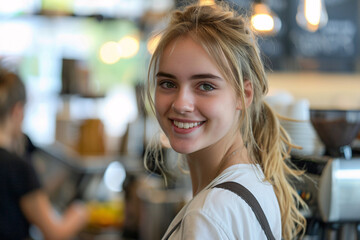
[296,0,328,32]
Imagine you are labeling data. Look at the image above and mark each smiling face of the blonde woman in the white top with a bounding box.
[155,36,241,154]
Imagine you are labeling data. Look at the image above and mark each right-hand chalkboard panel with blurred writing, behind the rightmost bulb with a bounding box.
[289,0,360,71]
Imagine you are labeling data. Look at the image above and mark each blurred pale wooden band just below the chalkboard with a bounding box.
[268,72,360,109]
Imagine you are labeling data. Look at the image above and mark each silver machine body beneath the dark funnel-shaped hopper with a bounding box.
[291,154,360,240]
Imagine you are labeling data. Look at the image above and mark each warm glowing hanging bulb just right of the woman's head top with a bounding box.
[251,0,281,35]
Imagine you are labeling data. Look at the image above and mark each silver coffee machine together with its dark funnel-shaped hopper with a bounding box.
[291,109,360,240]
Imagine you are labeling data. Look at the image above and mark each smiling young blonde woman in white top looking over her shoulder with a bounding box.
[146,2,305,240]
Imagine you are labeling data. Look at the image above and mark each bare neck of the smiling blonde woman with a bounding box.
[186,134,250,196]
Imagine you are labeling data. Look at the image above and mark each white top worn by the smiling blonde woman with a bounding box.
[163,164,281,240]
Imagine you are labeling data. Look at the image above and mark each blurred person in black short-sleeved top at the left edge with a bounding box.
[0,61,88,240]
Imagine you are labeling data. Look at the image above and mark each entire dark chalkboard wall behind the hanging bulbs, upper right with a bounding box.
[177,0,360,72]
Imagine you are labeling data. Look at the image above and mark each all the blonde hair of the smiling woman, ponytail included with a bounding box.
[145,4,306,239]
